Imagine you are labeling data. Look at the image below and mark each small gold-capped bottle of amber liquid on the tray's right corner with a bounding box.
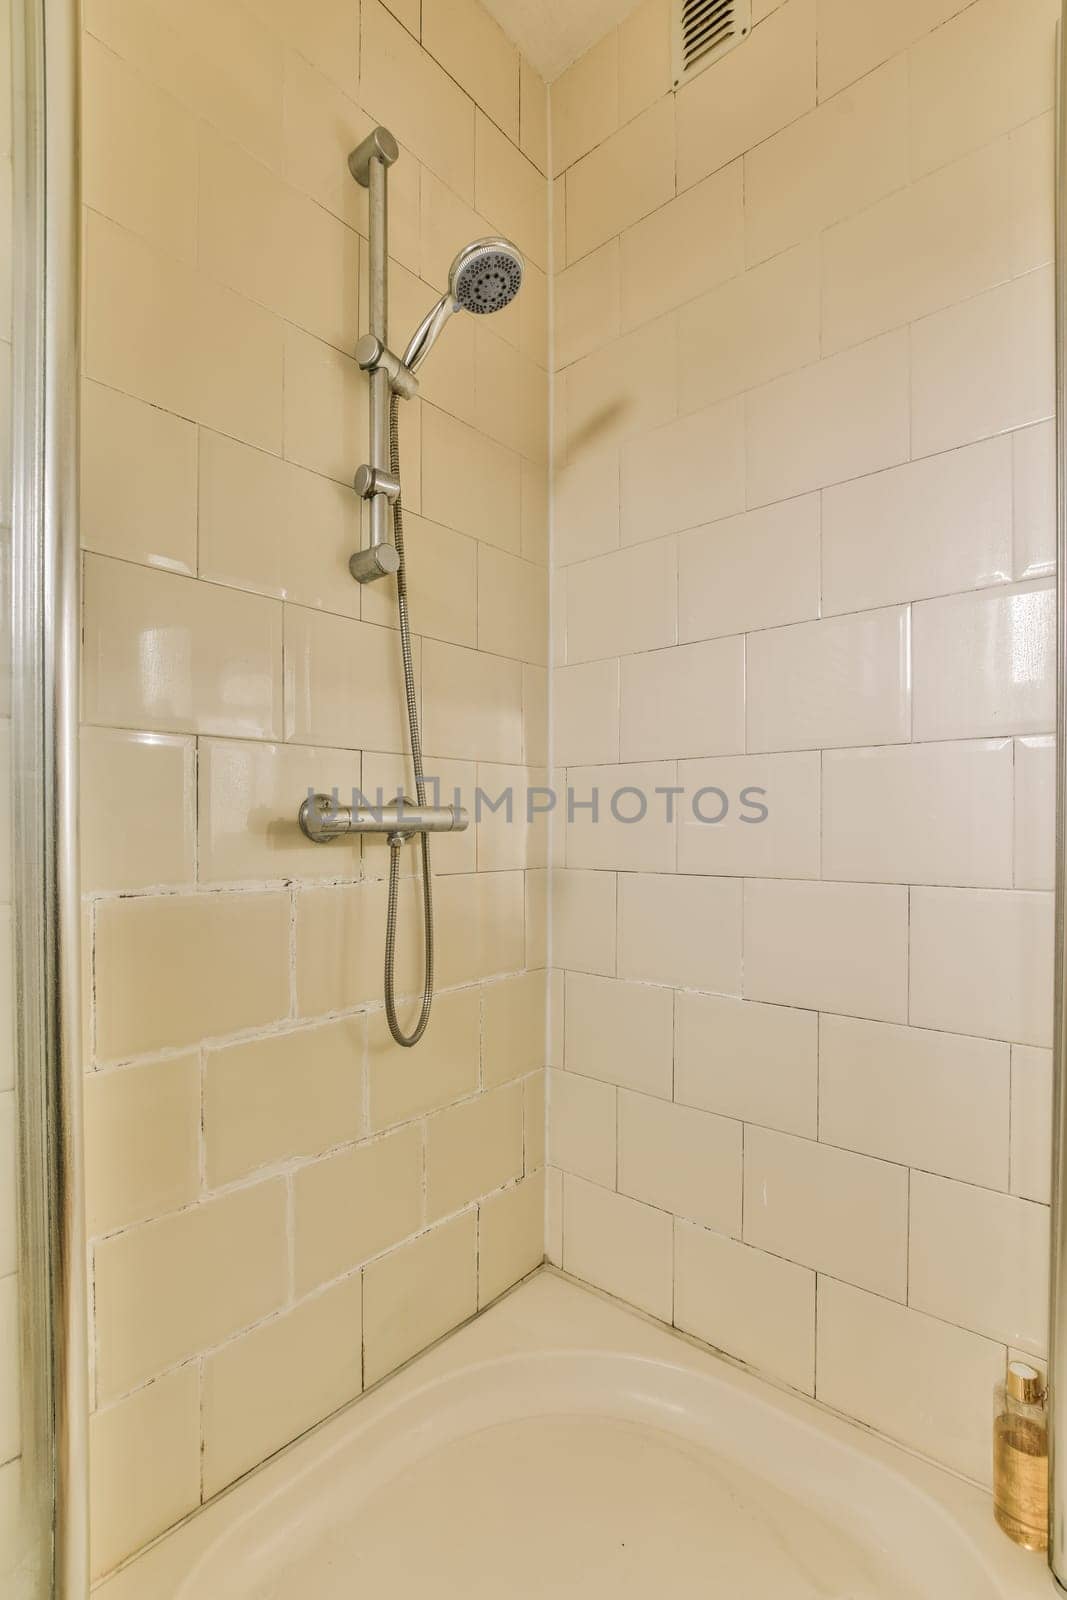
[993,1362,1048,1550]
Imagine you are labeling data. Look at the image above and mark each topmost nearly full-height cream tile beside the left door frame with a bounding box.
[82,35,197,261]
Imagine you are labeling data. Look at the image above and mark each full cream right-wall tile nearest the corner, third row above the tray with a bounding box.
[566,973,673,1099]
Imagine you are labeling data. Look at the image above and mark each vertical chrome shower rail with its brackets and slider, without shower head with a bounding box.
[349,128,404,584]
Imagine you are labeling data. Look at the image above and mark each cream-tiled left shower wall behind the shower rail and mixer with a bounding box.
[82,0,549,1573]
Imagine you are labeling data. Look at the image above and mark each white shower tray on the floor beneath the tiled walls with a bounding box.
[96,1272,1059,1600]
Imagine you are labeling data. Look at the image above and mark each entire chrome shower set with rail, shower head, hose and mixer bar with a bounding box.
[299,128,525,1048]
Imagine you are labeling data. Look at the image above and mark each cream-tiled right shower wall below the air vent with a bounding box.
[549,0,1057,1478]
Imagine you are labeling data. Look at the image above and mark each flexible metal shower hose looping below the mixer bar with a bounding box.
[386,394,434,1050]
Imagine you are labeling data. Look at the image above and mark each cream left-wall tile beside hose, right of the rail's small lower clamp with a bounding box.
[422,406,522,554]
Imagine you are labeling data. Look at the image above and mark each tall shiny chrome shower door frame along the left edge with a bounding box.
[11,0,90,1600]
